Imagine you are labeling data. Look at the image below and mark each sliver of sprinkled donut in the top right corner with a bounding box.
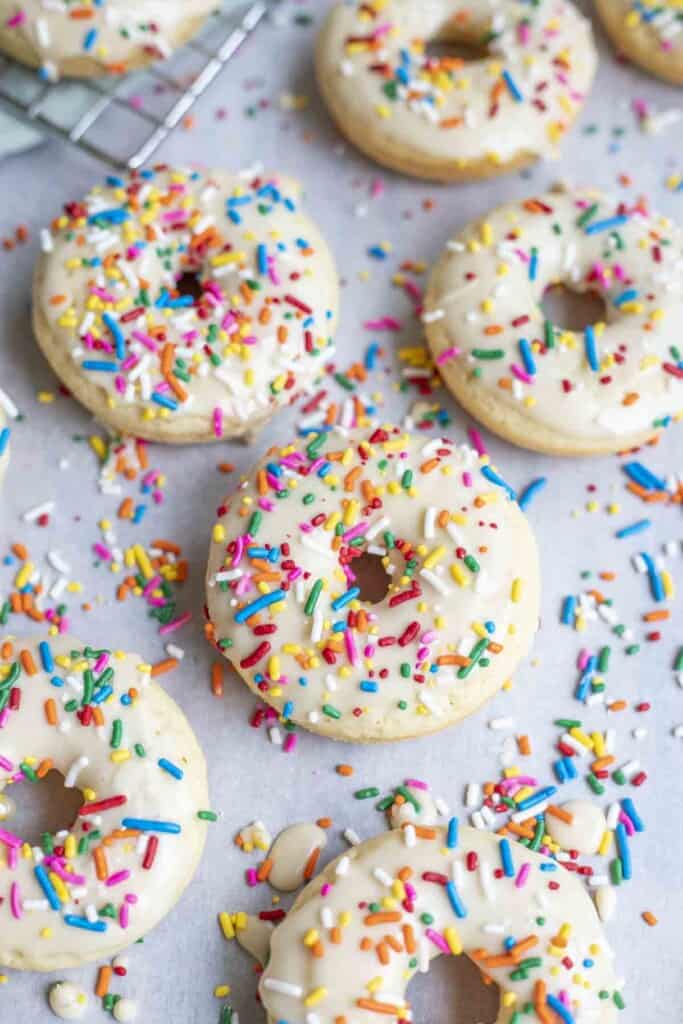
[596,0,683,85]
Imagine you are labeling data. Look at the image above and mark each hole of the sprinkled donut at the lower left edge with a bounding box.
[3,771,84,846]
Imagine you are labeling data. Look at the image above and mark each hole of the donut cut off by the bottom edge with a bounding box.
[408,955,500,1024]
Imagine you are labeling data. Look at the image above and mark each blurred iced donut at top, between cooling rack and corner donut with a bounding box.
[316,0,597,181]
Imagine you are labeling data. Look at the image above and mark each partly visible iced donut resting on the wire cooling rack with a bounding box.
[0,0,218,81]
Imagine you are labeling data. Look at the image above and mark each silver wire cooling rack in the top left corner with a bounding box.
[0,0,276,170]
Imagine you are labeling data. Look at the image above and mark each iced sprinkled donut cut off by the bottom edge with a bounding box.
[259,818,621,1024]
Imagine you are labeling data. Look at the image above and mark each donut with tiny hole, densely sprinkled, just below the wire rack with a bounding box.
[33,167,338,443]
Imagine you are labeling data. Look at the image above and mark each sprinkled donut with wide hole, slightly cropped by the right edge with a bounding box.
[423,190,683,455]
